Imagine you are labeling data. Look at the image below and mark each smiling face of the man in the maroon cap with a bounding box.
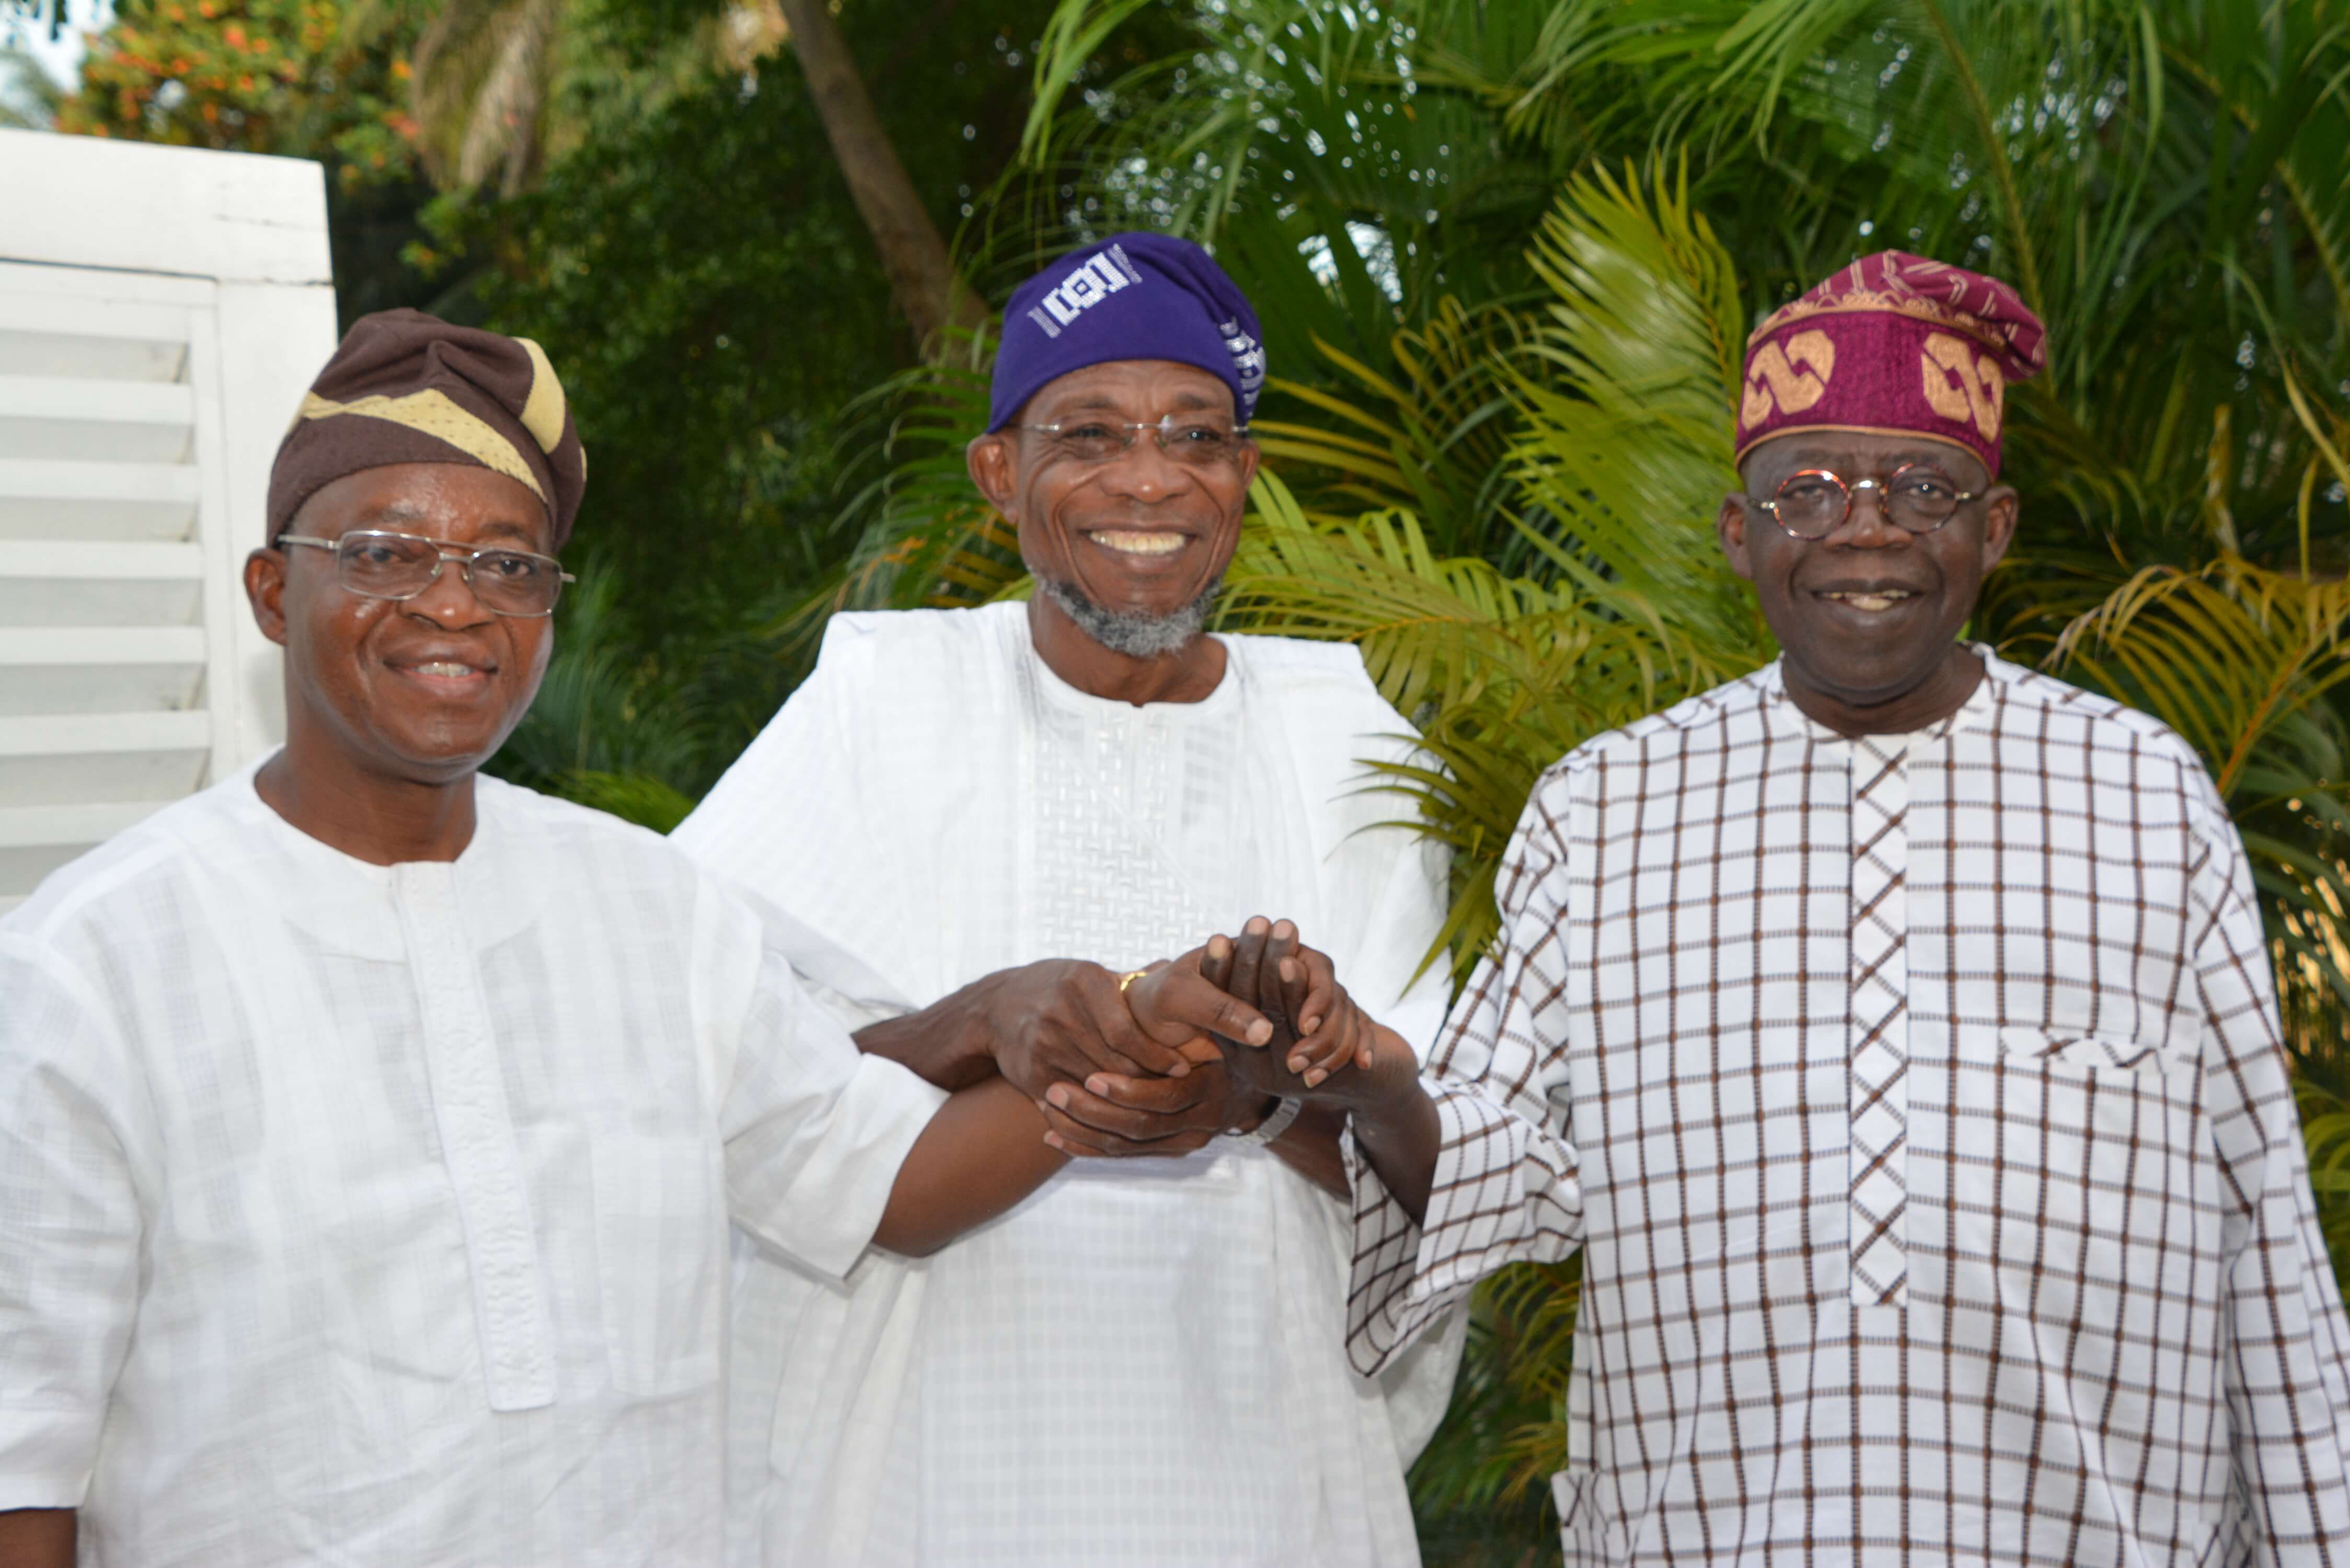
[1718,430,2017,733]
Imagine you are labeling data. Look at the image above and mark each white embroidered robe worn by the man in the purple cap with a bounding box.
[677,604,1457,1568]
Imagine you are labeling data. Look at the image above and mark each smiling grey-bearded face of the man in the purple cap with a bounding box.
[971,360,1257,639]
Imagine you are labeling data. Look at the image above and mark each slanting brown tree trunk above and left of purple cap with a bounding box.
[780,0,987,353]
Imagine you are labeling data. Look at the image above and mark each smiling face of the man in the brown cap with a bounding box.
[245,463,555,783]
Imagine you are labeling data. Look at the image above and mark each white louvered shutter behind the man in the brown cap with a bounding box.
[0,132,333,912]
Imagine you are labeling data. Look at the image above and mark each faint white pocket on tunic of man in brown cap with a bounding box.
[590,1133,726,1397]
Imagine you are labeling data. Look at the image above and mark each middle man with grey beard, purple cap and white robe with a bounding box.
[677,235,1457,1568]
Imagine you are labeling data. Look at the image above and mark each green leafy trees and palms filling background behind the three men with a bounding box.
[32,0,2350,1563]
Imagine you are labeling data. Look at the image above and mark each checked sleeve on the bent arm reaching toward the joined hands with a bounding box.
[1346,774,1584,1375]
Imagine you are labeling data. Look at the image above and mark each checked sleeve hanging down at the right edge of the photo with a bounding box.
[2195,802,2350,1563]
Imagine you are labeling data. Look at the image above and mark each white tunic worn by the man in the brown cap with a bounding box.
[0,771,940,1568]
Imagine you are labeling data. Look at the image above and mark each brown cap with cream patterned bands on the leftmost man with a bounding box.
[270,310,588,550]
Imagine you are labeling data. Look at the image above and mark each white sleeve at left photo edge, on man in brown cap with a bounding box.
[0,933,141,1509]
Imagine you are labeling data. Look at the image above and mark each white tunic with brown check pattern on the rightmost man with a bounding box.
[1349,653,2350,1568]
